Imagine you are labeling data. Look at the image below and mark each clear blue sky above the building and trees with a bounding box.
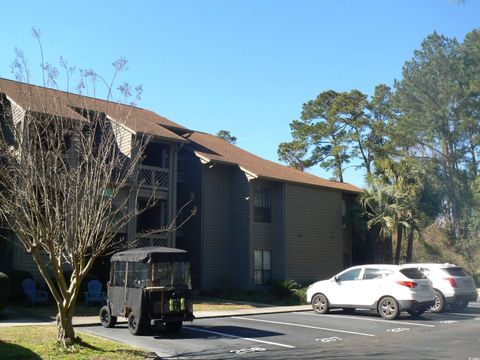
[0,0,480,186]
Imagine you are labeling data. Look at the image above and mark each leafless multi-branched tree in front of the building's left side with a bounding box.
[0,31,194,346]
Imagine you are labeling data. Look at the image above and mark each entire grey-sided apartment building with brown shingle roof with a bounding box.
[0,79,361,289]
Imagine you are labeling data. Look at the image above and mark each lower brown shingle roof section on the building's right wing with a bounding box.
[187,132,362,193]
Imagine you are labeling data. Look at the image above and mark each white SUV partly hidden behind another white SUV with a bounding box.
[402,263,478,312]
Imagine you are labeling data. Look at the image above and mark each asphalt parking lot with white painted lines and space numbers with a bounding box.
[79,302,480,359]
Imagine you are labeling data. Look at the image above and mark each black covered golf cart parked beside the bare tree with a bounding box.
[100,246,195,335]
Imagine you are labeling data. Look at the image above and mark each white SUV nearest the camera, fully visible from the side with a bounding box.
[307,265,435,320]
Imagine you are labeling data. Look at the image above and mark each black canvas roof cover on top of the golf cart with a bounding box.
[110,246,187,263]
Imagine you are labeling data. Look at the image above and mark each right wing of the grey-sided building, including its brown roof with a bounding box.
[177,132,360,288]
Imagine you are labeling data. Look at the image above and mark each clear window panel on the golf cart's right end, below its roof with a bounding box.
[152,262,191,289]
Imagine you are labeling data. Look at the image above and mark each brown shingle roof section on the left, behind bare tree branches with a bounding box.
[0,78,187,142]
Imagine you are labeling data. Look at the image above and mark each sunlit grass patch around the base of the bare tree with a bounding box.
[0,326,146,360]
